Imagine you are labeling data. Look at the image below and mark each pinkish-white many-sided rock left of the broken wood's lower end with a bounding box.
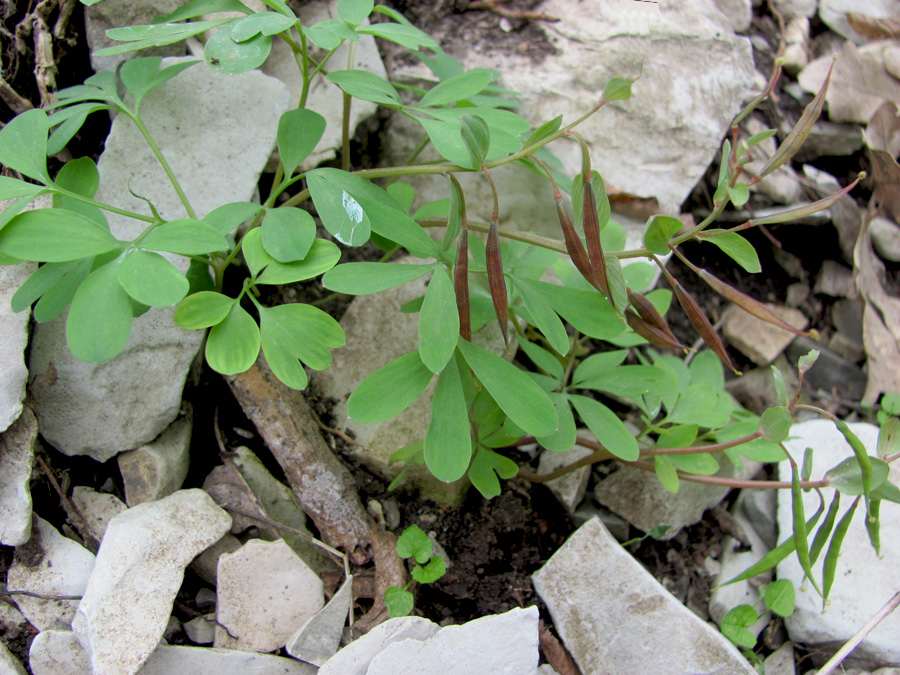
[214,539,325,652]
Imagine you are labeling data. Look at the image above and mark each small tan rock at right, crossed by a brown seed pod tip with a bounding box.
[722,303,809,366]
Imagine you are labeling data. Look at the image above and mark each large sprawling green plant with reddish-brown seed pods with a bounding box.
[0,0,898,628]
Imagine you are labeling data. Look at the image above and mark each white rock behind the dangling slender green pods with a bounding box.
[777,420,900,665]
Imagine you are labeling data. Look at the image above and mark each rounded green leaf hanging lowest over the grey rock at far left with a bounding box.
[66,263,133,363]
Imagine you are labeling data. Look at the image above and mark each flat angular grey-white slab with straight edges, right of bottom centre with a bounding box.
[532,518,756,675]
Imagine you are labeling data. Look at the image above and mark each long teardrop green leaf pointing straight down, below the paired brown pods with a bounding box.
[425,360,474,483]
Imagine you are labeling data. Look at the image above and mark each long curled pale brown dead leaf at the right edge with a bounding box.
[853,219,900,403]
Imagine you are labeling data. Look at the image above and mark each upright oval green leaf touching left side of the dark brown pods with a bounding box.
[419,267,459,373]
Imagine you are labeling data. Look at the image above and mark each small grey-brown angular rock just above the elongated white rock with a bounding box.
[116,414,193,506]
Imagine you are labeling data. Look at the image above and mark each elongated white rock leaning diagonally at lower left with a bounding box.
[72,490,231,675]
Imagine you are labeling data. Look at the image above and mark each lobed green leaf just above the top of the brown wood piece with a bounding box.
[258,303,346,389]
